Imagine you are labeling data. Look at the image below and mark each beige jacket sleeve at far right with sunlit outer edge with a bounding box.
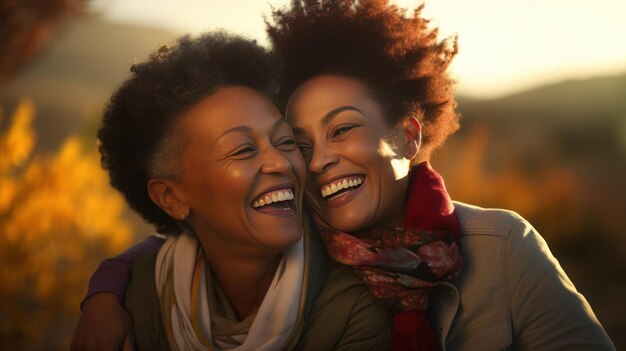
[506,220,615,350]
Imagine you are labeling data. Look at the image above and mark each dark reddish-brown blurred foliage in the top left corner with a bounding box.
[0,0,86,80]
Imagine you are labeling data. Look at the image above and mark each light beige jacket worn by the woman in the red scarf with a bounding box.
[428,202,615,350]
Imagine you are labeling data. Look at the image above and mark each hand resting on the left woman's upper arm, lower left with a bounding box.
[71,292,135,351]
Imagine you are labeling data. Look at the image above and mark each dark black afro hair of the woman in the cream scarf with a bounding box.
[98,32,278,234]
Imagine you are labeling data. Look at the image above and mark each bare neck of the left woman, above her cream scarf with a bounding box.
[200,240,282,320]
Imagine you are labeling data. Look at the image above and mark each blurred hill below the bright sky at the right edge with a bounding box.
[459,73,626,162]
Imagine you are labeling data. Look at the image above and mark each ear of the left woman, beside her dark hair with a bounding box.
[148,178,189,221]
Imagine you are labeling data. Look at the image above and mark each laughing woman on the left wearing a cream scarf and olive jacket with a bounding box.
[72,32,390,350]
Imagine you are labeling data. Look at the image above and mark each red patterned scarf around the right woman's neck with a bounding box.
[317,163,463,351]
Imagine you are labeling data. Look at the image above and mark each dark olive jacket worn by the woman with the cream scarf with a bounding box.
[126,214,391,351]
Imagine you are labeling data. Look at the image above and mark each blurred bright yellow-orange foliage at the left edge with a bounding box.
[0,102,133,350]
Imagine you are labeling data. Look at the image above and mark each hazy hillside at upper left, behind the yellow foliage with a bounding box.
[0,15,177,150]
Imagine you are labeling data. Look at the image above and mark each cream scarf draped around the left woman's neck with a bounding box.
[155,233,304,351]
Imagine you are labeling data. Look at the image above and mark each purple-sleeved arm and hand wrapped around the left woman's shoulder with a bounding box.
[71,236,164,351]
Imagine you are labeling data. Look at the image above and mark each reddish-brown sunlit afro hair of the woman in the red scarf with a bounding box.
[266,0,459,158]
